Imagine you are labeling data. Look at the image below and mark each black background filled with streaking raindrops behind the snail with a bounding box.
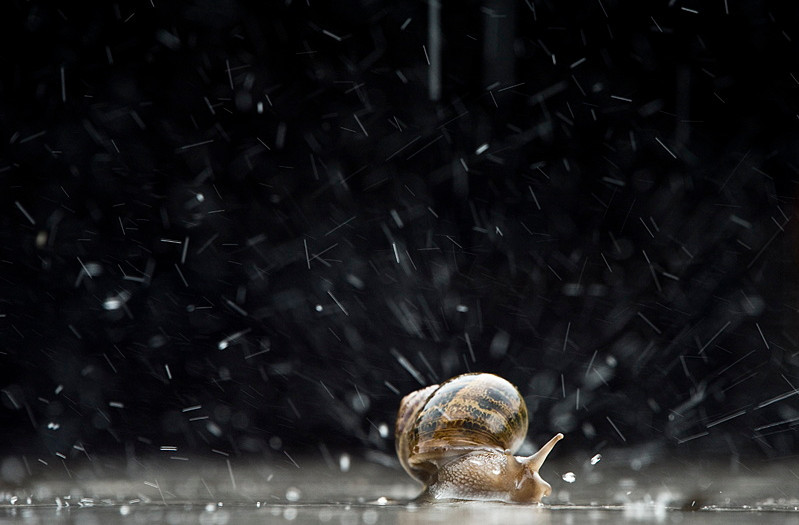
[0,0,799,469]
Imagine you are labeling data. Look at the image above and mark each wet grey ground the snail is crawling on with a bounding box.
[0,455,799,525]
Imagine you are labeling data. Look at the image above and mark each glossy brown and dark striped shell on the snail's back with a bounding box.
[395,374,528,484]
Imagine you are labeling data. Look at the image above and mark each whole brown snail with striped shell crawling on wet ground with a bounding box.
[395,373,563,503]
